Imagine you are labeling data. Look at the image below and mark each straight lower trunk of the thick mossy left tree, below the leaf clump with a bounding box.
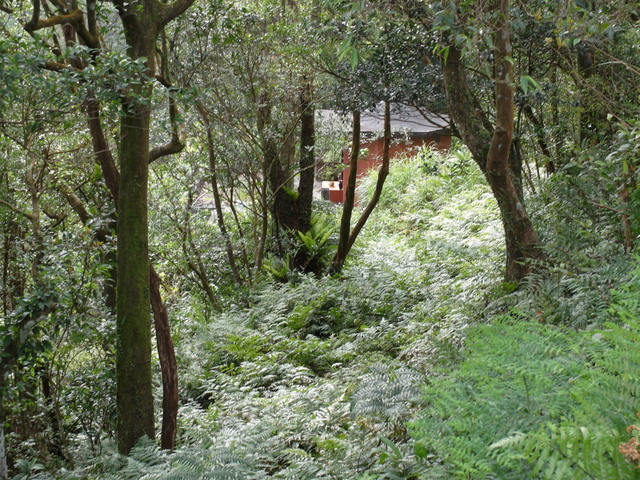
[116,100,155,454]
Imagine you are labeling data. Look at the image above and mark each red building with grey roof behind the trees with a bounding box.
[323,103,451,203]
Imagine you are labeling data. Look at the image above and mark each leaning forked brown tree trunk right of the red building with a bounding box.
[443,0,545,282]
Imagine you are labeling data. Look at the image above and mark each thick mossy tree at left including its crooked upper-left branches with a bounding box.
[1,0,193,453]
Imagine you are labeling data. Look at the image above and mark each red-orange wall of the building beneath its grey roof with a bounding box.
[329,134,451,203]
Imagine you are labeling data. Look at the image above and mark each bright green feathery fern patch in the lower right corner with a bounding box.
[415,314,640,479]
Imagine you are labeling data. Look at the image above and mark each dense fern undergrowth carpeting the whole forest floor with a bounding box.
[25,151,640,480]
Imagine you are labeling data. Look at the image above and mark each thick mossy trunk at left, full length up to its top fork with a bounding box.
[114,0,193,454]
